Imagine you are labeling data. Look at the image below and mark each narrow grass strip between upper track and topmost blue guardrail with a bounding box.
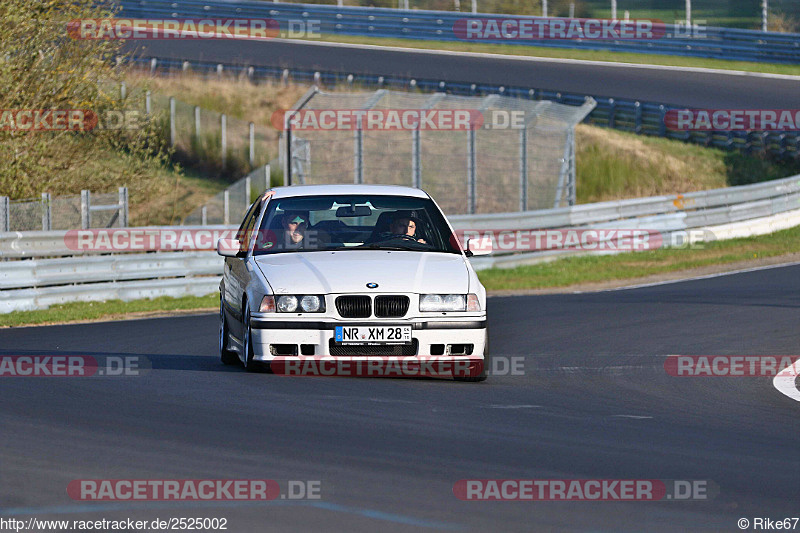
[296,34,800,76]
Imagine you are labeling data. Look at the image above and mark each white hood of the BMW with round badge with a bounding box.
[255,250,469,294]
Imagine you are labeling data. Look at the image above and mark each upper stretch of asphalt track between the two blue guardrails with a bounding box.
[125,40,800,109]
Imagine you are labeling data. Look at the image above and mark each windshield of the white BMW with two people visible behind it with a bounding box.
[254,195,461,255]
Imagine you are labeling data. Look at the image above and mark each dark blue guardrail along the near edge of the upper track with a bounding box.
[131,57,800,159]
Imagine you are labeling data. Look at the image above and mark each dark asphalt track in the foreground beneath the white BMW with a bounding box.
[0,266,800,532]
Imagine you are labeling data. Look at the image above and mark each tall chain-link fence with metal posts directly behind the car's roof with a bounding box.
[281,90,596,214]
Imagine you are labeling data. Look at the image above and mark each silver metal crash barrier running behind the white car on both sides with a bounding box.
[0,172,800,313]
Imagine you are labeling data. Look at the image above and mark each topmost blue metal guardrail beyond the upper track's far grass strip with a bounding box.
[121,0,800,63]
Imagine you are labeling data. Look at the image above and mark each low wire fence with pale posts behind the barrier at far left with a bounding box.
[0,187,128,232]
